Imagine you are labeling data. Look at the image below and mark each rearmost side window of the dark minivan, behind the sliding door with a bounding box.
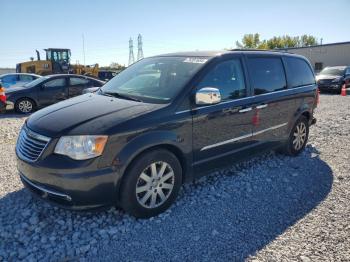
[285,57,315,88]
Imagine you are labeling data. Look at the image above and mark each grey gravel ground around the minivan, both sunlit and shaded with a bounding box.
[0,95,350,262]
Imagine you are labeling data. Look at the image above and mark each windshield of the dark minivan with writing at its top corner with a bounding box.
[100,57,208,103]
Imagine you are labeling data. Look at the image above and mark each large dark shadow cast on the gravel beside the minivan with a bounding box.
[0,145,333,261]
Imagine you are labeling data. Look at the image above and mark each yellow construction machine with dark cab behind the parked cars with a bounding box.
[16,48,98,78]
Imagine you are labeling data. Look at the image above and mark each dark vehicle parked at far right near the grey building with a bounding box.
[316,66,350,93]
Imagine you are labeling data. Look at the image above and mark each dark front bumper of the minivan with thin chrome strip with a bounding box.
[17,155,119,210]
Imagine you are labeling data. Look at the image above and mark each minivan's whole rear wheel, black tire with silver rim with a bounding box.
[279,116,309,156]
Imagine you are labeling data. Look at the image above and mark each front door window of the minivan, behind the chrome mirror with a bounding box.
[197,59,247,101]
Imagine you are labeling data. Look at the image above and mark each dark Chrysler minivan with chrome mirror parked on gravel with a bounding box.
[16,50,318,218]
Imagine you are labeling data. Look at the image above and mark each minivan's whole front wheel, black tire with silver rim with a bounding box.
[120,149,182,218]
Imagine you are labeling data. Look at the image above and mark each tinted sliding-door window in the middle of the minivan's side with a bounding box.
[248,57,287,95]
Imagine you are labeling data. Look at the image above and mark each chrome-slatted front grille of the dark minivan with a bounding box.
[16,126,50,162]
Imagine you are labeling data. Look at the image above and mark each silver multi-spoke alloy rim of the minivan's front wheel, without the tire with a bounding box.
[136,161,175,208]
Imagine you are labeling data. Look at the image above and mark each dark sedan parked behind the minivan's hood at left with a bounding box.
[6,74,104,113]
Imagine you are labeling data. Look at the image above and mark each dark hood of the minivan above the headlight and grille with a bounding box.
[27,94,164,138]
